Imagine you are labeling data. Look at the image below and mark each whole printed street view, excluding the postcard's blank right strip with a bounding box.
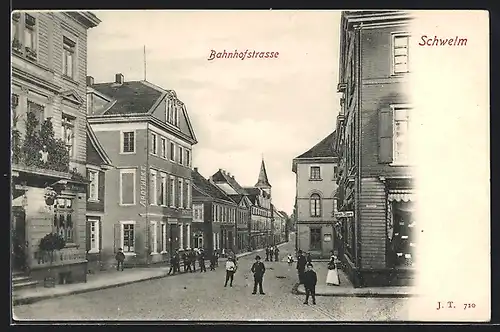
[10,11,421,321]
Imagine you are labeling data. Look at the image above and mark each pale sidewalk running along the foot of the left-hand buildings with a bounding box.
[12,243,285,305]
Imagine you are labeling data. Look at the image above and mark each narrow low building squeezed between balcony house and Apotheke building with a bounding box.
[85,122,113,272]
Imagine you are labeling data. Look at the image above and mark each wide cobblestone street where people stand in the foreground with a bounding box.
[14,244,408,321]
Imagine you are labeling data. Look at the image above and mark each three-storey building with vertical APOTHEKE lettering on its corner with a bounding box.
[87,74,197,265]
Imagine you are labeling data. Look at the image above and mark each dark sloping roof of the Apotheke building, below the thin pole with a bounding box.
[91,81,163,115]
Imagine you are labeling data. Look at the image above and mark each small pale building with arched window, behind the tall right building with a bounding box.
[292,131,338,258]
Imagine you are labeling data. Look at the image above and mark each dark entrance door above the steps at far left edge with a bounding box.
[12,207,27,271]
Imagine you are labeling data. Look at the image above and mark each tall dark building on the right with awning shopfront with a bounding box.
[335,11,415,286]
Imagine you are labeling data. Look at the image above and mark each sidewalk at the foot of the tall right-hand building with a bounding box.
[294,261,418,297]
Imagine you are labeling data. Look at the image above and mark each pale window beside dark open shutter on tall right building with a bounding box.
[393,108,410,163]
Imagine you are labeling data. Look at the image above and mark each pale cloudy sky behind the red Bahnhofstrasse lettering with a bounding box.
[88,10,340,214]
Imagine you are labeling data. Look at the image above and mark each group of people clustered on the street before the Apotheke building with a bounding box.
[168,248,219,274]
